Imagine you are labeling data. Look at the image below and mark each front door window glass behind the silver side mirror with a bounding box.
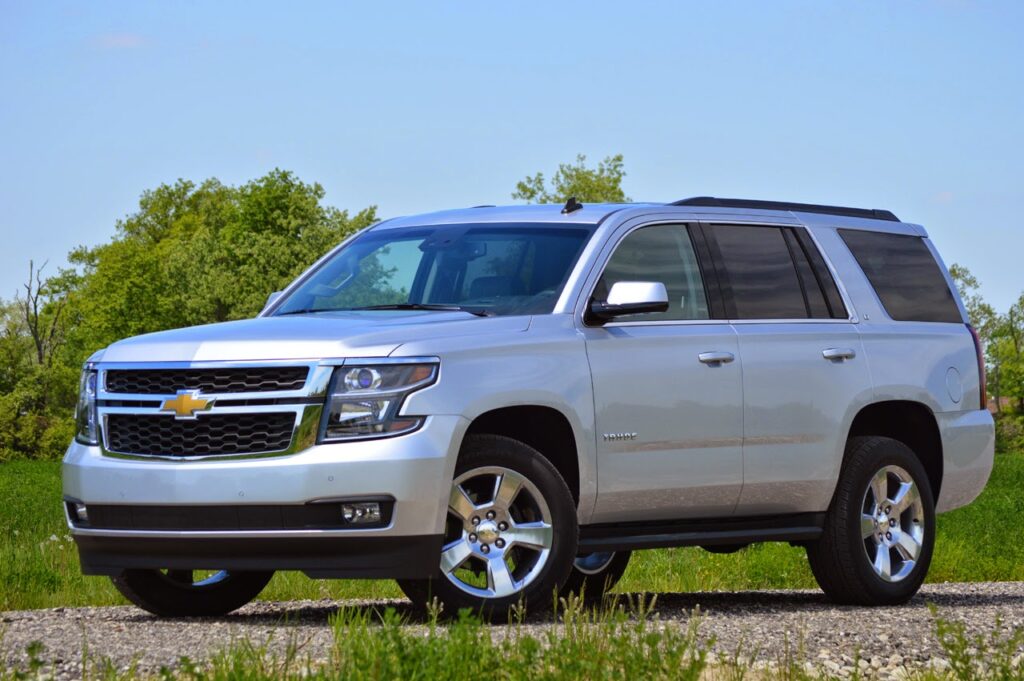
[594,224,711,322]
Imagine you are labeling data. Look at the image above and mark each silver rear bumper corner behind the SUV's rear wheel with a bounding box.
[935,410,995,513]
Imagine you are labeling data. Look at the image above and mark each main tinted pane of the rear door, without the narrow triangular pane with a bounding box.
[711,224,809,320]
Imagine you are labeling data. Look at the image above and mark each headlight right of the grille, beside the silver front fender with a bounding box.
[321,364,437,442]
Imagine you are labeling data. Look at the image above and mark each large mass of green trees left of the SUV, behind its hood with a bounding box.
[0,170,376,461]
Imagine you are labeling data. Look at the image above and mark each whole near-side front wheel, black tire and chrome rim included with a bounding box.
[398,435,579,622]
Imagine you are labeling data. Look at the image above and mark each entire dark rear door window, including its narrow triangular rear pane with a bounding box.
[710,224,846,320]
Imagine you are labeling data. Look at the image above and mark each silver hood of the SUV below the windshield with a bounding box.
[96,310,530,363]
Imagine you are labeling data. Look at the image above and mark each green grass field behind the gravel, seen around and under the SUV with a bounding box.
[0,452,1024,610]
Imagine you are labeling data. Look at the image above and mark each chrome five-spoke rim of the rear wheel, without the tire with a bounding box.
[860,466,925,582]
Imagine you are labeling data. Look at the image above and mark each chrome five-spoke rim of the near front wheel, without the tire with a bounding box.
[441,466,554,598]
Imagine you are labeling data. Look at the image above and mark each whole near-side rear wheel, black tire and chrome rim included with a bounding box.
[807,437,935,605]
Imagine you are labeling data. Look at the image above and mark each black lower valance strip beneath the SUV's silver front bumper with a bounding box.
[75,535,441,579]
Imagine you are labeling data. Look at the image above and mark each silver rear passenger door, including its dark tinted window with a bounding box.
[703,223,871,516]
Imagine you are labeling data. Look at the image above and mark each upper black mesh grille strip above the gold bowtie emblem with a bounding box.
[105,367,309,395]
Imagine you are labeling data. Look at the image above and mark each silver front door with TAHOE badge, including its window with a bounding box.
[583,224,743,523]
